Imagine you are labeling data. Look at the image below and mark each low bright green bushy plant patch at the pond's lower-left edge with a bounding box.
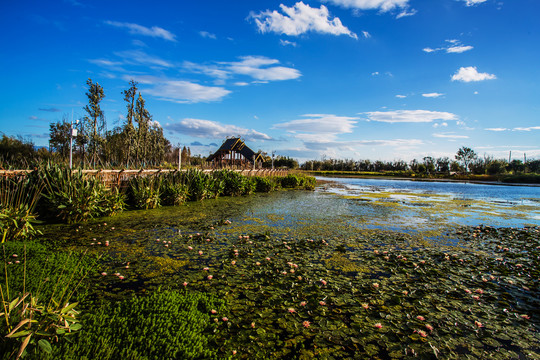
[54,290,224,360]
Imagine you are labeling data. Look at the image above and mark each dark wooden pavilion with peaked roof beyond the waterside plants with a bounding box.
[206,137,264,168]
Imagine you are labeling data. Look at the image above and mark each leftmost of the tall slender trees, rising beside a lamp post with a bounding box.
[84,79,105,167]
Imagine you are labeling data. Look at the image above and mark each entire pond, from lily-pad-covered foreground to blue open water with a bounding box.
[42,178,540,359]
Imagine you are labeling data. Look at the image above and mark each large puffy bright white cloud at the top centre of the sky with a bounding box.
[250,1,358,39]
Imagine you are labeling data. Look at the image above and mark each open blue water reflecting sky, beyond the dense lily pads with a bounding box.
[231,178,540,233]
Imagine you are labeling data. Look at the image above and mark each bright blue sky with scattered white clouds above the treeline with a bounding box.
[0,0,540,162]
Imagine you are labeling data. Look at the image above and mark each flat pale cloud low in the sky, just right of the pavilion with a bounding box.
[274,114,358,134]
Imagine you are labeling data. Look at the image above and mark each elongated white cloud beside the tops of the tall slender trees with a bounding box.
[124,76,231,104]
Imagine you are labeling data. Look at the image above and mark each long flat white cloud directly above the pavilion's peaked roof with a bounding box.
[164,118,272,141]
